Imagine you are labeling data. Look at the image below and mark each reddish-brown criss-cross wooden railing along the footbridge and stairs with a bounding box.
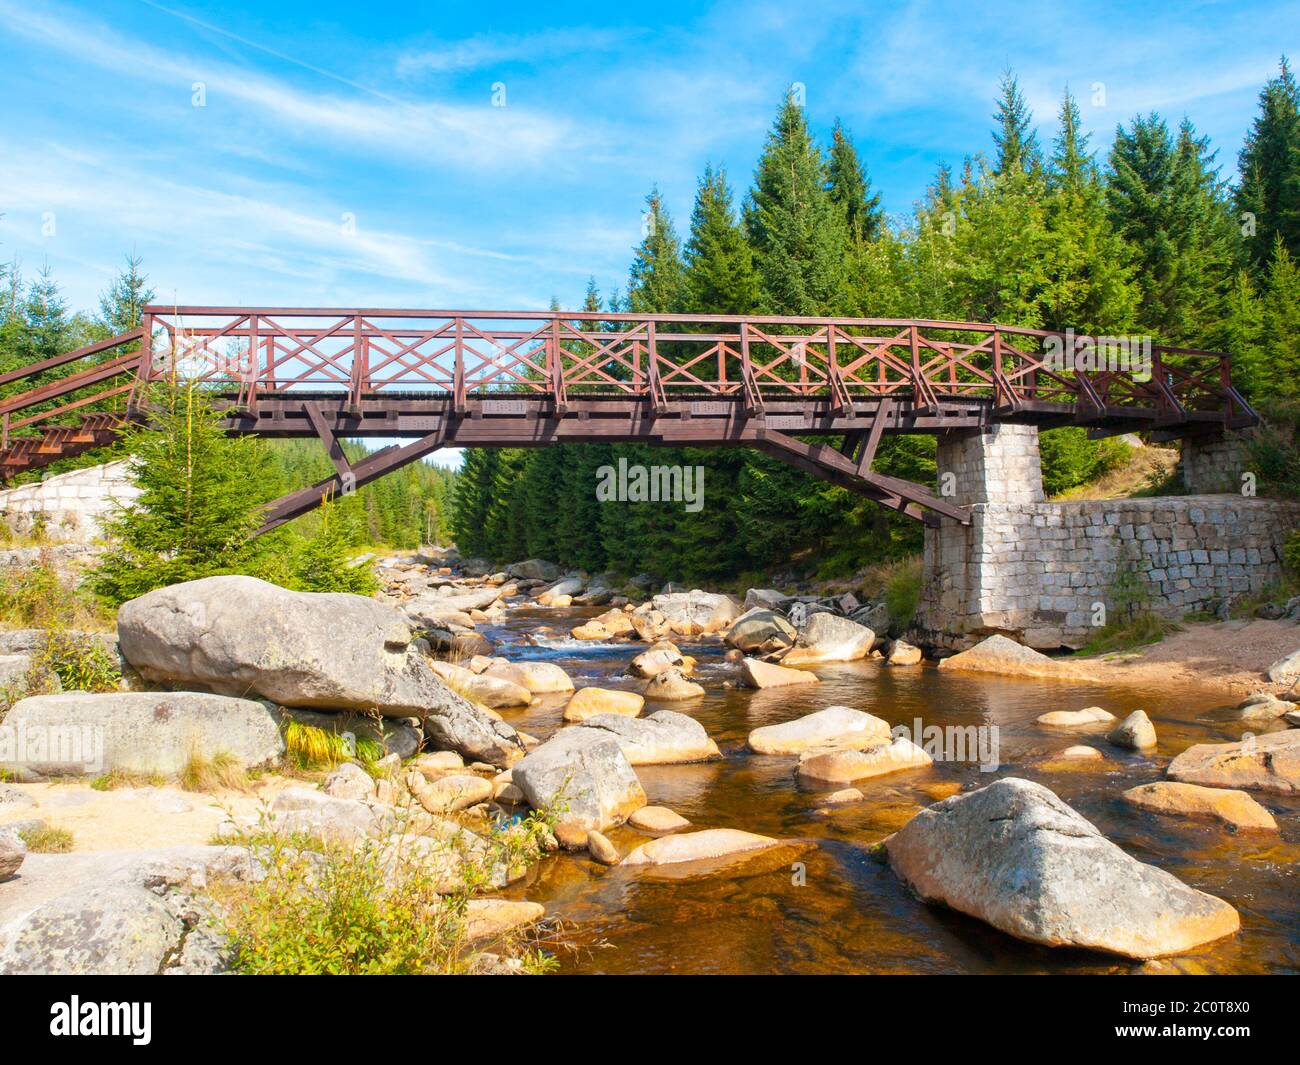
[0,306,1252,444]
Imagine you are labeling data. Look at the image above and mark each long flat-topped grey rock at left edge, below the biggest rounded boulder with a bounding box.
[0,692,285,776]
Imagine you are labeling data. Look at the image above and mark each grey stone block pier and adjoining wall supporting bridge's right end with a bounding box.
[917,427,1300,649]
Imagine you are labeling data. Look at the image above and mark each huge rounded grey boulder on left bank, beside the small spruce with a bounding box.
[117,576,460,718]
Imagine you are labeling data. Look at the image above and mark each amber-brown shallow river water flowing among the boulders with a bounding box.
[484,609,1300,973]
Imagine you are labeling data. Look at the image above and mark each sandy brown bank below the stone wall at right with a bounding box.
[1070,619,1300,698]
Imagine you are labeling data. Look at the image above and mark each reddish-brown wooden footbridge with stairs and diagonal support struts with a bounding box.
[0,306,1257,531]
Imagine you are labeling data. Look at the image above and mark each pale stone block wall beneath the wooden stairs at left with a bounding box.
[0,460,140,544]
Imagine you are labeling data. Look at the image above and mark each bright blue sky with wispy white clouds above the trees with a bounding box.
[0,0,1300,321]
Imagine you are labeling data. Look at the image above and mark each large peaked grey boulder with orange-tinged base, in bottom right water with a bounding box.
[885,778,1240,958]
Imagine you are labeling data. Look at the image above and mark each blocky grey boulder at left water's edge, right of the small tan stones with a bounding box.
[511,718,646,831]
